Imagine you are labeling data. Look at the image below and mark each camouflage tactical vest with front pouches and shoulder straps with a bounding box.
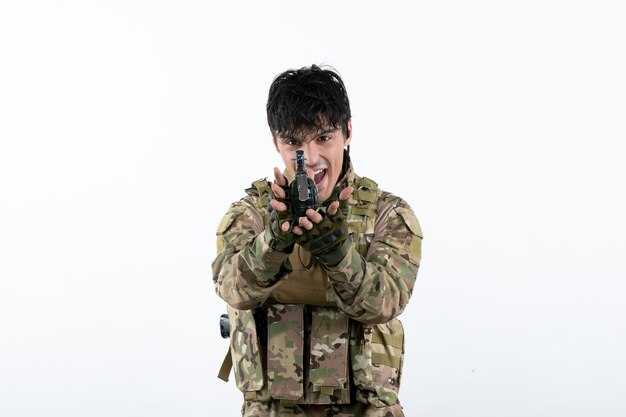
[220,177,404,407]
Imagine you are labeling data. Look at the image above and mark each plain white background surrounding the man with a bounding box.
[0,0,626,417]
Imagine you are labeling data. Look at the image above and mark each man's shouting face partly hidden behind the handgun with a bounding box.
[275,122,352,201]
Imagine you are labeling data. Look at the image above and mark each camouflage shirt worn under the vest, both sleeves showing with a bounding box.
[212,161,422,323]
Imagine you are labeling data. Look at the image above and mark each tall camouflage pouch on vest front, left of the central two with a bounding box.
[267,304,304,401]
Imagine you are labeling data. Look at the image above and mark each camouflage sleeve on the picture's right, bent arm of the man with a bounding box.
[324,197,422,324]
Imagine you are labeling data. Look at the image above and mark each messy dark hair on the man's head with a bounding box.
[267,65,352,138]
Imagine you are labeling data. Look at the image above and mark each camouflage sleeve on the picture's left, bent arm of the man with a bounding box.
[212,199,291,310]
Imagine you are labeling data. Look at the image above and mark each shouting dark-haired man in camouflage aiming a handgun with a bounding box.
[213,65,422,417]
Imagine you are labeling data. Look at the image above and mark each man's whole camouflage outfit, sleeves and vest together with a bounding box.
[213,165,422,417]
